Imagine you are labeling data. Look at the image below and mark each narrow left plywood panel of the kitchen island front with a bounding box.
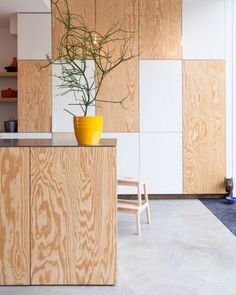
[0,148,30,285]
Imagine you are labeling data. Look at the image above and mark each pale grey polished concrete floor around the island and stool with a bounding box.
[0,200,236,295]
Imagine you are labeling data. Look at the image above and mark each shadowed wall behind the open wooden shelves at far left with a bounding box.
[0,28,17,132]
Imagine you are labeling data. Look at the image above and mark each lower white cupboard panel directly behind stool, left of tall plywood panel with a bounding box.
[140,133,182,194]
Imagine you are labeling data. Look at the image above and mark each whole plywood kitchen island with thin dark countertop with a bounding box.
[0,139,117,285]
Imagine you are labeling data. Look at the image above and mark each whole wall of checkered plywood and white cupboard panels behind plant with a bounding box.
[15,0,228,195]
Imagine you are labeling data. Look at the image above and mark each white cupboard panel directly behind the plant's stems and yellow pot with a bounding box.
[52,62,95,132]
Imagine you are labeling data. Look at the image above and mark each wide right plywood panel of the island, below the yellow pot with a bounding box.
[31,147,117,285]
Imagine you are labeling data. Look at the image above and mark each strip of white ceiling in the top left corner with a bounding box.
[0,0,50,14]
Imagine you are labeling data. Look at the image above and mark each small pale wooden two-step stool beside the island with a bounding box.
[117,178,151,236]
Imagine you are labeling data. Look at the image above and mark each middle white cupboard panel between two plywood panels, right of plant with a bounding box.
[140,60,182,132]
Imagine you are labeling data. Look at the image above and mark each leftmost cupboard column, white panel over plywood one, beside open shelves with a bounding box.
[17,13,52,133]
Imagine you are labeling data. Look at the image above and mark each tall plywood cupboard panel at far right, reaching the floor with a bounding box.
[183,61,225,193]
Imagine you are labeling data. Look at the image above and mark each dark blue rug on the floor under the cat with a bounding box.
[199,199,236,235]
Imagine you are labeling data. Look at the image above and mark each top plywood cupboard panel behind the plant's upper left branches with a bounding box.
[52,0,95,58]
